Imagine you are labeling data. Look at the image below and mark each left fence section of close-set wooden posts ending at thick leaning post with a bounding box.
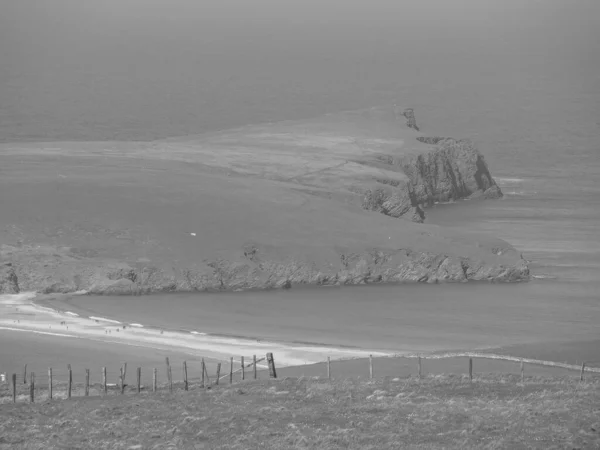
[0,353,277,403]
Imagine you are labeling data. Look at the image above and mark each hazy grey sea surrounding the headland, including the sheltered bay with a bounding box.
[0,0,600,363]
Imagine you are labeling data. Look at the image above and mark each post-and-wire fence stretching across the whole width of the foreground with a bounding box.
[0,352,600,403]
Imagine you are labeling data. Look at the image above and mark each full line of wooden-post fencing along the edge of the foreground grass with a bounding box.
[0,352,600,403]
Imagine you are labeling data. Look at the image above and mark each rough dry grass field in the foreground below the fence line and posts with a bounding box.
[0,375,600,450]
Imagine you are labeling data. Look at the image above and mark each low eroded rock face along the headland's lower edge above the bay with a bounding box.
[5,244,529,295]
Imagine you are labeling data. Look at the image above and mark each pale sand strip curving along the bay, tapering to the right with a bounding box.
[0,293,390,368]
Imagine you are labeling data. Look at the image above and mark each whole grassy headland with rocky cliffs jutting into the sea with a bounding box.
[0,106,529,294]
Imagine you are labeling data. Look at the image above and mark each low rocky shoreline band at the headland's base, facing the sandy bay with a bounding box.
[0,249,530,295]
